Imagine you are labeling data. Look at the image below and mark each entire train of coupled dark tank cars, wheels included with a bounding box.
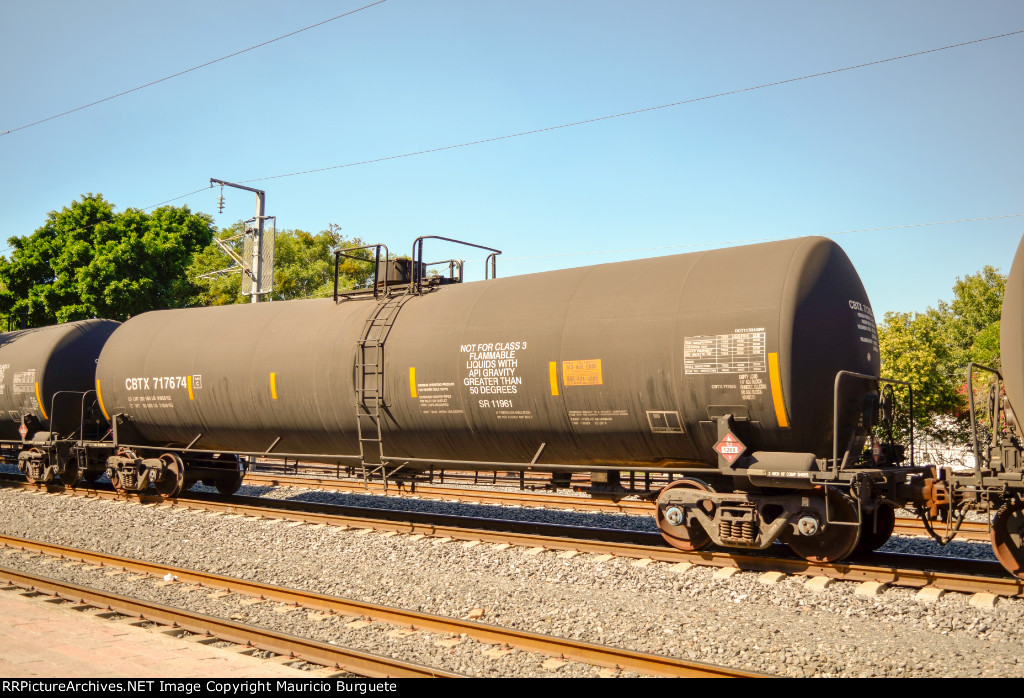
[6,237,1024,577]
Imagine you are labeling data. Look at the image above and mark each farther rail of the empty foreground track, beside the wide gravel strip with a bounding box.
[0,535,763,678]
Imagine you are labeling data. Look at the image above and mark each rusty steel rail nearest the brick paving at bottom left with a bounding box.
[0,567,463,679]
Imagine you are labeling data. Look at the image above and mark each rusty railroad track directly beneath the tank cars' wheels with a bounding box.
[2,480,1024,597]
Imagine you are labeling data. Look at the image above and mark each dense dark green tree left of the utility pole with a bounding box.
[0,193,215,326]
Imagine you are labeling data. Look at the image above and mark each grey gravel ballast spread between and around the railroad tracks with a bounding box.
[0,488,1024,677]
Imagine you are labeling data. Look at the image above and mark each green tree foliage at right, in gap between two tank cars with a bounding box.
[879,266,1007,443]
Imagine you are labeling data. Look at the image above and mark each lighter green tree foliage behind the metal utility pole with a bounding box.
[189,222,374,305]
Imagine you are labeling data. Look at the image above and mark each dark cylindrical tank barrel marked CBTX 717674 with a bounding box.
[97,236,878,469]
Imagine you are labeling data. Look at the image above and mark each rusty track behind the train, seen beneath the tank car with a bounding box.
[239,473,990,540]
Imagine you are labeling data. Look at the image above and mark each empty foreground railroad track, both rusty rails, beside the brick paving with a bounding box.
[0,535,761,678]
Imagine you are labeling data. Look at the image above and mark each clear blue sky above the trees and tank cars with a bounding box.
[0,0,1024,316]
